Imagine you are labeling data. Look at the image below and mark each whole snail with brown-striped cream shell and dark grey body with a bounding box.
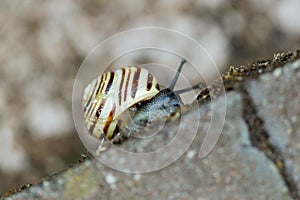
[82,59,202,151]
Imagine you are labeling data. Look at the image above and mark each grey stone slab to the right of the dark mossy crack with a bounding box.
[246,60,300,194]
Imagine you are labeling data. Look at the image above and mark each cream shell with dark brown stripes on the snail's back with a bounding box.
[83,67,159,139]
